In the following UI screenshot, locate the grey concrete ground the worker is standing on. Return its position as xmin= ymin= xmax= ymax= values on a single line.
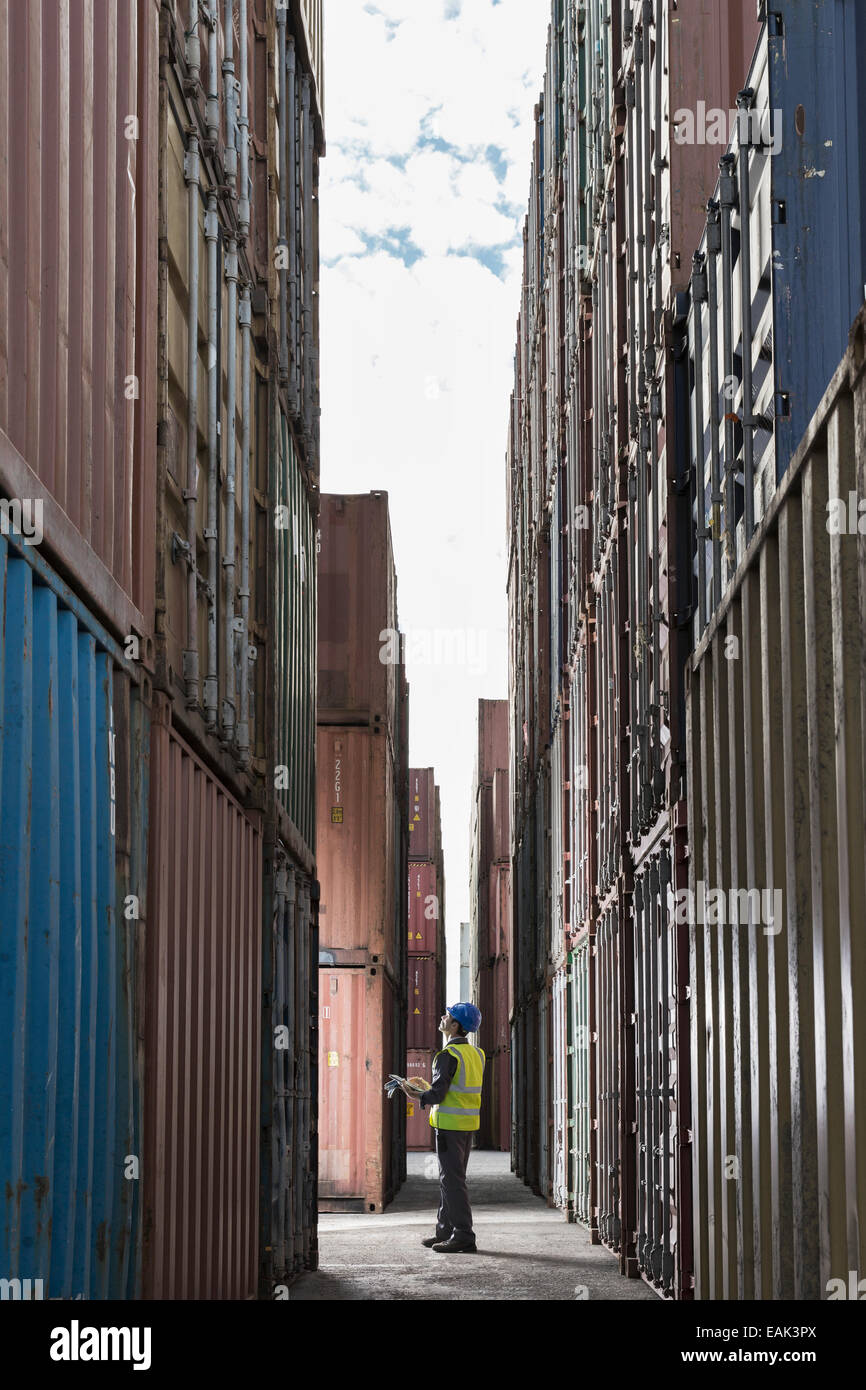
xmin=289 ymin=1151 xmax=657 ymax=1302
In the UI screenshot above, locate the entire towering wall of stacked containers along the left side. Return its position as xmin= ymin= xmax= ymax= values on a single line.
xmin=0 ymin=0 xmax=324 ymax=1298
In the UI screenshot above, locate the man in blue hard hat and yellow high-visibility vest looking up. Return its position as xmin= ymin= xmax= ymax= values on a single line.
xmin=403 ymin=1004 xmax=487 ymax=1255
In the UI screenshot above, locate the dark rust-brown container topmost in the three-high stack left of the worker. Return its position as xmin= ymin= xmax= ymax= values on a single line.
xmin=318 ymin=492 xmax=403 ymax=726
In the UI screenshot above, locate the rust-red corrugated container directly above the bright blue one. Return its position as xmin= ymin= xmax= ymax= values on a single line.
xmin=0 ymin=0 xmax=160 ymax=638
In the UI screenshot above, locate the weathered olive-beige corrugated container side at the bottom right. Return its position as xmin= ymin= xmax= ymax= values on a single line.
xmin=681 ymin=314 xmax=866 ymax=1300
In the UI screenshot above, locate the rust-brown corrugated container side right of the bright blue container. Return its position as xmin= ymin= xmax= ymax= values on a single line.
xmin=142 ymin=699 xmax=263 ymax=1298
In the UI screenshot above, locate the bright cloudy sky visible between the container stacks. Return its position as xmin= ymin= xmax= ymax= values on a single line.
xmin=321 ymin=0 xmax=550 ymax=998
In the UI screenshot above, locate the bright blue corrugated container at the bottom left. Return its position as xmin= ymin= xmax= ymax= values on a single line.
xmin=0 ymin=535 xmax=146 ymax=1298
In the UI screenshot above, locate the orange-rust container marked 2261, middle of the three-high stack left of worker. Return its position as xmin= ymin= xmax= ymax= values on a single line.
xmin=317 ymin=727 xmax=407 ymax=972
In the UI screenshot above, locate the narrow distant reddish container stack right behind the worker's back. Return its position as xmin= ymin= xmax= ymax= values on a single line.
xmin=467 ymin=699 xmax=512 ymax=1151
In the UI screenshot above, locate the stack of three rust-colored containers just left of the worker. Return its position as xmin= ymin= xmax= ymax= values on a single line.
xmin=317 ymin=492 xmax=409 ymax=1211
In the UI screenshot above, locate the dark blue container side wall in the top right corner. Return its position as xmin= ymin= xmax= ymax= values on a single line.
xmin=769 ymin=0 xmax=866 ymax=480
